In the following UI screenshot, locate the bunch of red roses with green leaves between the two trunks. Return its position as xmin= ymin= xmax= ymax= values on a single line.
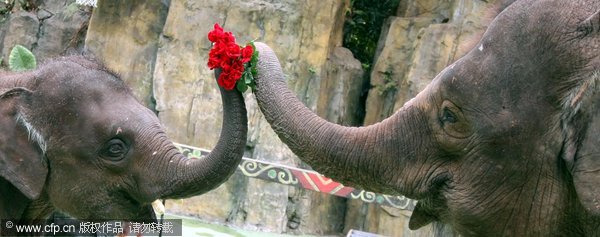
xmin=208 ymin=24 xmax=258 ymax=92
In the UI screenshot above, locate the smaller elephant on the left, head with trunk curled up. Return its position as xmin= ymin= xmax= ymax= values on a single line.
xmin=0 ymin=56 xmax=247 ymax=220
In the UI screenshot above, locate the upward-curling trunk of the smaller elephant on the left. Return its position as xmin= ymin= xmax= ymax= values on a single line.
xmin=144 ymin=74 xmax=248 ymax=199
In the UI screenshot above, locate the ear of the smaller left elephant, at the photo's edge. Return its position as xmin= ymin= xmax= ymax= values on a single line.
xmin=0 ymin=88 xmax=48 ymax=199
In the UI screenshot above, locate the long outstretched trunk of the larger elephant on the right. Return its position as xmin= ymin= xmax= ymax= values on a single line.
xmin=254 ymin=43 xmax=428 ymax=196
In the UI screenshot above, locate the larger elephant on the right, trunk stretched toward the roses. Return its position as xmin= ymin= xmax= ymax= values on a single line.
xmin=253 ymin=0 xmax=600 ymax=236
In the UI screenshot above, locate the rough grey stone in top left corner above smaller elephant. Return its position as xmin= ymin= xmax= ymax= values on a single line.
xmin=0 ymin=0 xmax=91 ymax=66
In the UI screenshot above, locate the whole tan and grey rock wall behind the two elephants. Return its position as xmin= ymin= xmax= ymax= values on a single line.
xmin=0 ymin=0 xmax=506 ymax=236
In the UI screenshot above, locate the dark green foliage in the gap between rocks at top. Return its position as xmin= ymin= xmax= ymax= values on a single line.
xmin=344 ymin=0 xmax=400 ymax=69
